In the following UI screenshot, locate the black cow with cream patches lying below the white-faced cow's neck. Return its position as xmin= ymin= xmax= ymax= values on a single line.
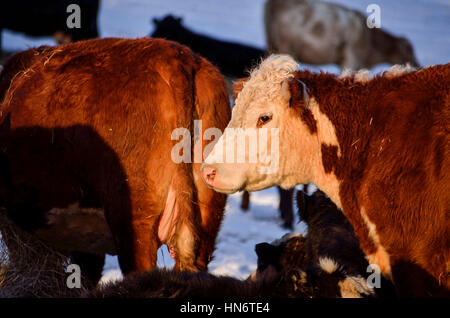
xmin=249 ymin=191 xmax=395 ymax=297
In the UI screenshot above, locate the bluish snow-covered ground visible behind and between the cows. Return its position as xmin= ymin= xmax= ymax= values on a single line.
xmin=3 ymin=0 xmax=450 ymax=281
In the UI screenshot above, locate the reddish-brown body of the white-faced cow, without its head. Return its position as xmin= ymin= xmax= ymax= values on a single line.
xmin=288 ymin=64 xmax=450 ymax=296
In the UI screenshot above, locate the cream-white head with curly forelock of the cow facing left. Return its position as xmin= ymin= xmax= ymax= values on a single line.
xmin=202 ymin=55 xmax=318 ymax=193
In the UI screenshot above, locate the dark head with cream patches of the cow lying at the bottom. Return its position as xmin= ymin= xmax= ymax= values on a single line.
xmin=247 ymin=233 xmax=375 ymax=298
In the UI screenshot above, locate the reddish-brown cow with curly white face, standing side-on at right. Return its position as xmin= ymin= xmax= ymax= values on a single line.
xmin=202 ymin=55 xmax=450 ymax=296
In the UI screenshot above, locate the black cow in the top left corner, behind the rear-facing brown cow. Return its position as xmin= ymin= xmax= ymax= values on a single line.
xmin=0 ymin=0 xmax=100 ymax=50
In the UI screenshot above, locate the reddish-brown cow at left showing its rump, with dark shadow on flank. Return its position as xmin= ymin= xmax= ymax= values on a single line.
xmin=0 ymin=38 xmax=230 ymax=278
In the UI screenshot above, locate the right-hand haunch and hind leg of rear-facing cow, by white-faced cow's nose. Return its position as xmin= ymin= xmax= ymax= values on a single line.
xmin=192 ymin=58 xmax=231 ymax=270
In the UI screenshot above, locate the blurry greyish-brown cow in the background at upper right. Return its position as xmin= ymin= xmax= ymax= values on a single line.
xmin=264 ymin=0 xmax=418 ymax=70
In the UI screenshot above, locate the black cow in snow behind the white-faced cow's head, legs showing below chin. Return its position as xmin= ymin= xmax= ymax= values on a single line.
xmin=151 ymin=15 xmax=294 ymax=229
